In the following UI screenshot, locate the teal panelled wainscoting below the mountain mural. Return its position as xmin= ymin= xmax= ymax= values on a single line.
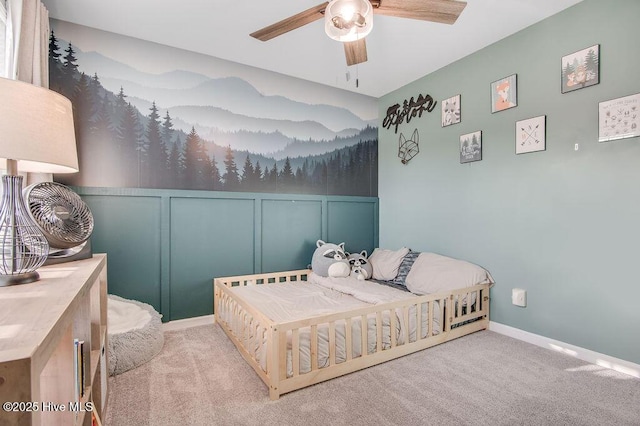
xmin=74 ymin=187 xmax=378 ymax=321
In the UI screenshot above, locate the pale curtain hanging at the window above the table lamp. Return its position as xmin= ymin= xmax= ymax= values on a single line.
xmin=7 ymin=0 xmax=49 ymax=88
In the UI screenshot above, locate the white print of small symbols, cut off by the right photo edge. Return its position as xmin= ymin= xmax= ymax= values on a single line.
xmin=598 ymin=93 xmax=640 ymax=142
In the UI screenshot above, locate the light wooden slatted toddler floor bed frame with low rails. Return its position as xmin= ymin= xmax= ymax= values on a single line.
xmin=213 ymin=269 xmax=490 ymax=400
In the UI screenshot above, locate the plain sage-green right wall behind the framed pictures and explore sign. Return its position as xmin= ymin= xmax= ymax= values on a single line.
xmin=379 ymin=0 xmax=640 ymax=363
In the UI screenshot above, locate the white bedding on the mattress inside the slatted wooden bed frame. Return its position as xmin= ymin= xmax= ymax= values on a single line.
xmin=221 ymin=273 xmax=440 ymax=377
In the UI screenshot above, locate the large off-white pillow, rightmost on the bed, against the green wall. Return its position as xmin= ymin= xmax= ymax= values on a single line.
xmin=404 ymin=253 xmax=494 ymax=294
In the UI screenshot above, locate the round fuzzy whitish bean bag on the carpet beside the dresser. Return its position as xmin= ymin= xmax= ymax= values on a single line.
xmin=107 ymin=294 xmax=164 ymax=376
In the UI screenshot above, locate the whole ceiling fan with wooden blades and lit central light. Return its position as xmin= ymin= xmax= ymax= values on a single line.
xmin=251 ymin=0 xmax=467 ymax=65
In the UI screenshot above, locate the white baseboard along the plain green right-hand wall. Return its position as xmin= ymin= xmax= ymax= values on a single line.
xmin=489 ymin=321 xmax=640 ymax=379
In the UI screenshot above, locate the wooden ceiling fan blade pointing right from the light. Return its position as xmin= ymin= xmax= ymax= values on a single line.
xmin=371 ymin=0 xmax=467 ymax=24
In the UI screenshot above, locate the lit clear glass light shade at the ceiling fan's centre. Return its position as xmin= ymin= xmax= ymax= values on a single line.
xmin=324 ymin=0 xmax=373 ymax=42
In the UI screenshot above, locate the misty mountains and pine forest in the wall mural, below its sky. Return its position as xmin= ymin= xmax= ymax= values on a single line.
xmin=49 ymin=33 xmax=378 ymax=196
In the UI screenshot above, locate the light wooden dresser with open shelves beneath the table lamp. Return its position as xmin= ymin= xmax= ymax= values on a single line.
xmin=0 ymin=254 xmax=109 ymax=426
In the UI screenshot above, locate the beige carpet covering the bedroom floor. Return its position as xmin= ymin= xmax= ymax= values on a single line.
xmin=104 ymin=325 xmax=640 ymax=426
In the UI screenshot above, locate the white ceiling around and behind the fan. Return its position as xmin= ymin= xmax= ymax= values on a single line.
xmin=38 ymin=0 xmax=581 ymax=97
